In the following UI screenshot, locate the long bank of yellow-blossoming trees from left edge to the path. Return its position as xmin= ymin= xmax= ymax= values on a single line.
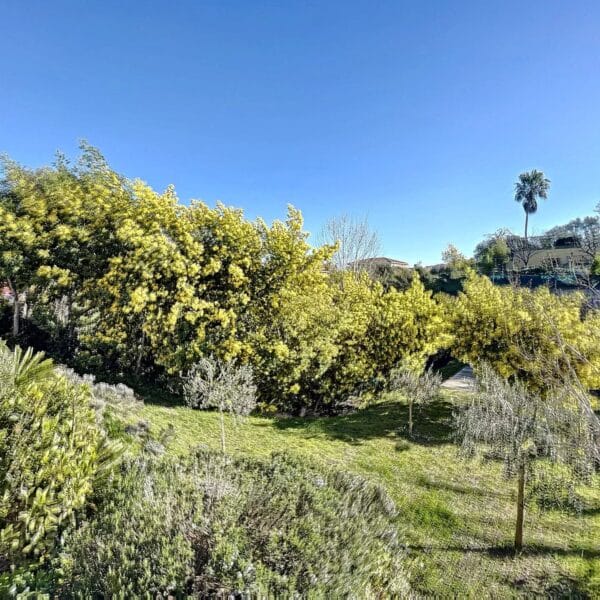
xmin=0 ymin=146 xmax=454 ymax=411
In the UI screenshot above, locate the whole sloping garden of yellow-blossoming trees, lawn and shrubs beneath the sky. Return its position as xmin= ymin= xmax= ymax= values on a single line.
xmin=0 ymin=145 xmax=600 ymax=598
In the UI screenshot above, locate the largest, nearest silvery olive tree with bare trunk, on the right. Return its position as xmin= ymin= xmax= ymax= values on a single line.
xmin=456 ymin=364 xmax=600 ymax=550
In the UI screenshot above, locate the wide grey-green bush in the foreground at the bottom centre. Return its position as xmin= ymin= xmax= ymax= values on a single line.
xmin=59 ymin=451 xmax=408 ymax=598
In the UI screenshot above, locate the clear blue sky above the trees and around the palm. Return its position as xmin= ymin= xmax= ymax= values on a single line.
xmin=0 ymin=0 xmax=600 ymax=264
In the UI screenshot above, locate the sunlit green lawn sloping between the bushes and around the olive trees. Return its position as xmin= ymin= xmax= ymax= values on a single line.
xmin=140 ymin=393 xmax=600 ymax=598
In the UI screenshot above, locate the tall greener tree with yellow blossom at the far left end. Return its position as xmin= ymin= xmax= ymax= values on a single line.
xmin=0 ymin=144 xmax=131 ymax=342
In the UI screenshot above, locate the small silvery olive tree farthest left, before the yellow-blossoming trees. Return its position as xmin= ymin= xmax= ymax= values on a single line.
xmin=182 ymin=357 xmax=256 ymax=453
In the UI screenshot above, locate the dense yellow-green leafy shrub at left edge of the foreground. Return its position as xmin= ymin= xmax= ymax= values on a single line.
xmin=0 ymin=344 xmax=116 ymax=566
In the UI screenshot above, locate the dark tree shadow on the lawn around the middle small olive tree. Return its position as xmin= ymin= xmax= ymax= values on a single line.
xmin=274 ymin=399 xmax=453 ymax=451
